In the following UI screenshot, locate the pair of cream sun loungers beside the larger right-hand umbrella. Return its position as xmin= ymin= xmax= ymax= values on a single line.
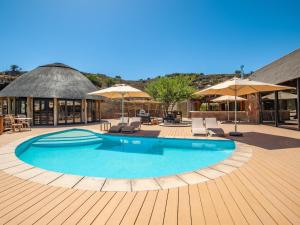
xmin=192 ymin=118 xmax=225 ymax=137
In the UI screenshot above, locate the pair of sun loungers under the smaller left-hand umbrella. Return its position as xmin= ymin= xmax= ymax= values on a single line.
xmin=108 ymin=117 xmax=141 ymax=133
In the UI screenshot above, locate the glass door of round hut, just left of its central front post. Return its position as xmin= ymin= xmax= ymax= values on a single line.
xmin=33 ymin=98 xmax=54 ymax=125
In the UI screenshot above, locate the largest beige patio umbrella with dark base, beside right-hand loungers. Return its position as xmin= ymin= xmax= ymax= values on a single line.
xmin=195 ymin=77 xmax=293 ymax=136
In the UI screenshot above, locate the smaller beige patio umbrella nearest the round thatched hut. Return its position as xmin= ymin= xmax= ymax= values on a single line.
xmin=88 ymin=84 xmax=150 ymax=123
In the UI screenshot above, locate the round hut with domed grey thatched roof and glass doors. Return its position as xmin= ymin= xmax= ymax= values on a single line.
xmin=0 ymin=63 xmax=100 ymax=126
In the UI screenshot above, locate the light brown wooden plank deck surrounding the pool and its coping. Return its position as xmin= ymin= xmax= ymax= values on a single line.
xmin=0 ymin=125 xmax=300 ymax=225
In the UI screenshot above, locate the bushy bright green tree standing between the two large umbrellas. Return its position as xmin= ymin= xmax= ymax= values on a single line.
xmin=146 ymin=76 xmax=195 ymax=113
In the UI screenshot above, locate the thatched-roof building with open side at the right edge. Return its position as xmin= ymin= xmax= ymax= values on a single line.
xmin=250 ymin=49 xmax=300 ymax=130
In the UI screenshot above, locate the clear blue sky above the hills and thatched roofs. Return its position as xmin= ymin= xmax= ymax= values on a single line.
xmin=0 ymin=0 xmax=300 ymax=79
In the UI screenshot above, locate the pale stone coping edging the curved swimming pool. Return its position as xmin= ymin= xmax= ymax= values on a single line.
xmin=0 ymin=128 xmax=252 ymax=191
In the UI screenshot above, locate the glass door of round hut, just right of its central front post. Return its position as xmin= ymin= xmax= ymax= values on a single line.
xmin=58 ymin=99 xmax=82 ymax=124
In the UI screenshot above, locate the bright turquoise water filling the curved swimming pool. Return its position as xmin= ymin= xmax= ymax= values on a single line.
xmin=16 ymin=129 xmax=235 ymax=178
